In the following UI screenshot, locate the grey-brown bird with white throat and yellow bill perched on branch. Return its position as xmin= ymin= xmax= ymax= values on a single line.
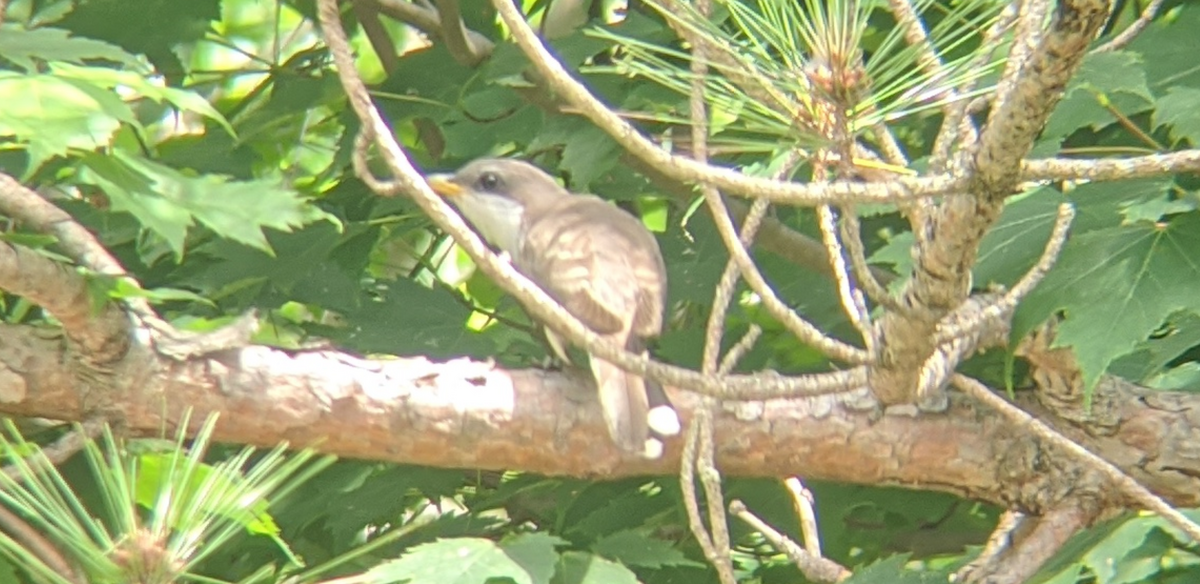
xmin=428 ymin=158 xmax=679 ymax=458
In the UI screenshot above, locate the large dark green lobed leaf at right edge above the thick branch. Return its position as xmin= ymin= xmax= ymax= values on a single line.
xmin=1013 ymin=212 xmax=1200 ymax=387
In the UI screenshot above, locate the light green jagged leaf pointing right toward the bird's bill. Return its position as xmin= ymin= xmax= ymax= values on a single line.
xmin=79 ymin=151 xmax=331 ymax=258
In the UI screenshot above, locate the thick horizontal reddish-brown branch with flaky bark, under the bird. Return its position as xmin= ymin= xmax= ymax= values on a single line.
xmin=0 ymin=326 xmax=1200 ymax=512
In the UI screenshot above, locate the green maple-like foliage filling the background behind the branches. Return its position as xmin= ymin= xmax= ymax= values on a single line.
xmin=0 ymin=0 xmax=1200 ymax=583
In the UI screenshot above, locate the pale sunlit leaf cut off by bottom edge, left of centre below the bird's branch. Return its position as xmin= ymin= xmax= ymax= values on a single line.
xmin=362 ymin=537 xmax=538 ymax=584
